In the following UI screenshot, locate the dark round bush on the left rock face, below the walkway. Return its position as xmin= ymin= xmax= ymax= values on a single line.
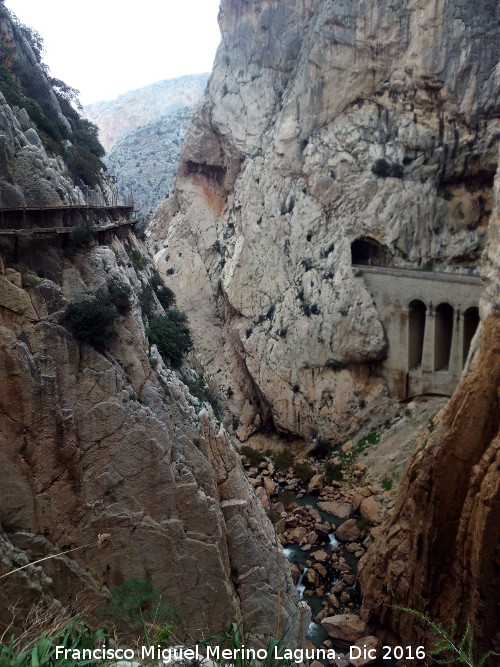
xmin=63 ymin=297 xmax=118 ymax=348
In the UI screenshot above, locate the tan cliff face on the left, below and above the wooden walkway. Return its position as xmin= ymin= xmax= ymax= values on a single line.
xmin=0 ymin=3 xmax=296 ymax=637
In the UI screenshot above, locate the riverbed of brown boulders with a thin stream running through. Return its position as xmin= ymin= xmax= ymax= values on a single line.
xmin=243 ymin=449 xmax=390 ymax=667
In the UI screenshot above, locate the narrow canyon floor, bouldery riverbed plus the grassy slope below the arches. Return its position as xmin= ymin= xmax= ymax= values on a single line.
xmin=236 ymin=396 xmax=448 ymax=664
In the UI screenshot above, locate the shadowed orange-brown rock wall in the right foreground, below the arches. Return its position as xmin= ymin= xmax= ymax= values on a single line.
xmin=360 ymin=154 xmax=500 ymax=664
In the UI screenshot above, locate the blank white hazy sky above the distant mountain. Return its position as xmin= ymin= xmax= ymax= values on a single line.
xmin=5 ymin=0 xmax=220 ymax=104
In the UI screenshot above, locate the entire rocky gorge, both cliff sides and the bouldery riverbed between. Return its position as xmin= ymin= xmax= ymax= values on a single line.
xmin=0 ymin=0 xmax=500 ymax=667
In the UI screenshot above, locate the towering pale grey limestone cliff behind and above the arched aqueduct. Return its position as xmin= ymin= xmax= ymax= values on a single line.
xmin=150 ymin=0 xmax=498 ymax=440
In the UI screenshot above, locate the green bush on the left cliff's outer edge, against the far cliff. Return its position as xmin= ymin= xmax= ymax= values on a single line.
xmin=148 ymin=308 xmax=193 ymax=368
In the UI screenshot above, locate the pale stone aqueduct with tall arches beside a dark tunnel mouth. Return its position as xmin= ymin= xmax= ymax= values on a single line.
xmin=353 ymin=241 xmax=483 ymax=400
